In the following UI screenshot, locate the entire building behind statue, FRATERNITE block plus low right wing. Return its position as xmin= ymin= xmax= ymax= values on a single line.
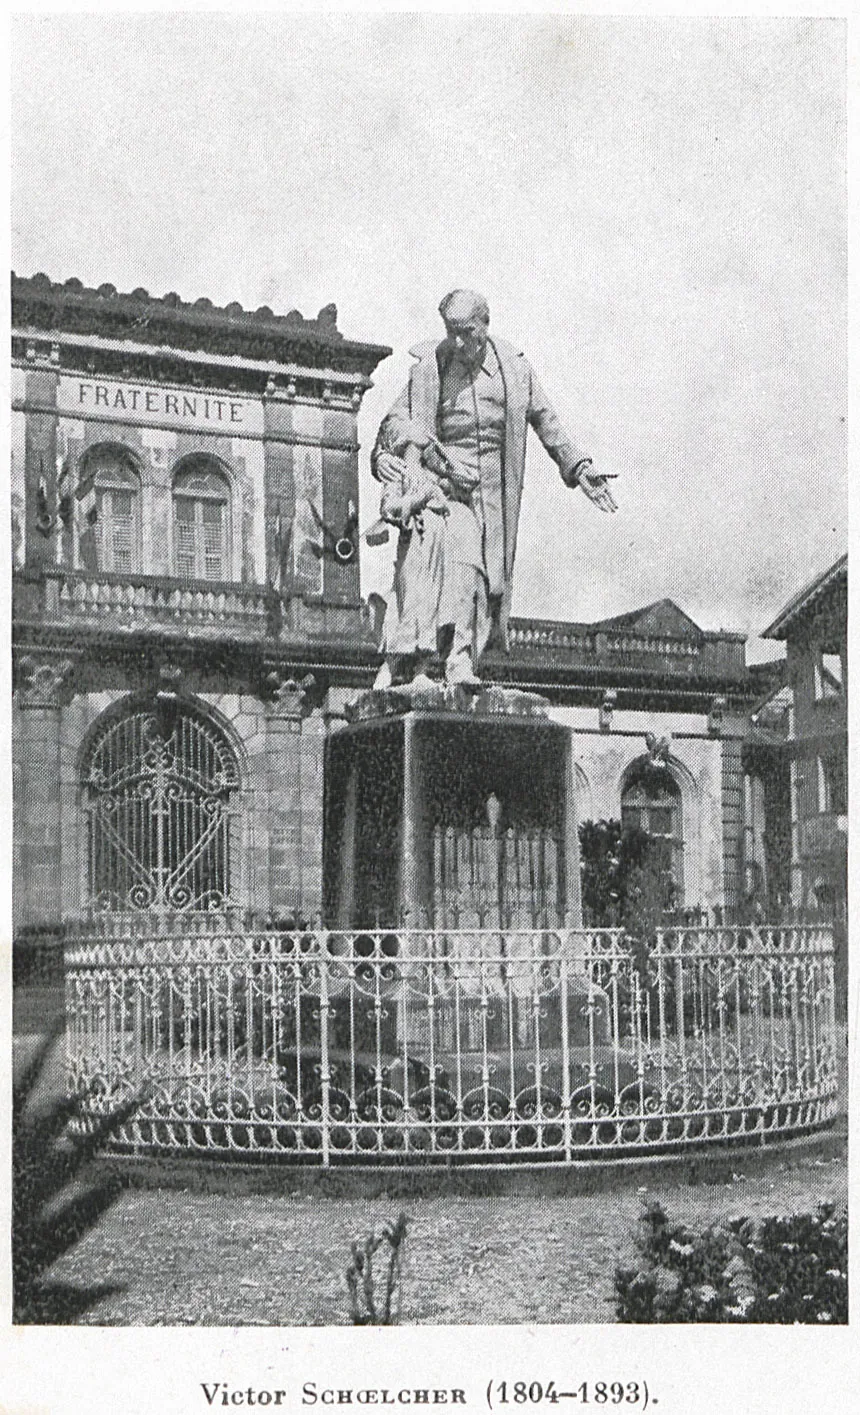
xmin=11 ymin=276 xmax=763 ymax=962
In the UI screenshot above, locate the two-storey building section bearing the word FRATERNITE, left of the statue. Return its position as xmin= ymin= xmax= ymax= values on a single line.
xmin=11 ymin=276 xmax=389 ymax=927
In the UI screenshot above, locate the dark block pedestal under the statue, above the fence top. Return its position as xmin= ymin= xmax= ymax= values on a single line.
xmin=324 ymin=685 xmax=581 ymax=930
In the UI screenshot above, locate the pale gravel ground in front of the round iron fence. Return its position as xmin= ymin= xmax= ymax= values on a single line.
xmin=42 ymin=1155 xmax=846 ymax=1326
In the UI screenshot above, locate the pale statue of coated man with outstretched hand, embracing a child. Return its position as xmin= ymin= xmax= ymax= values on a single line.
xmin=371 ymin=290 xmax=617 ymax=688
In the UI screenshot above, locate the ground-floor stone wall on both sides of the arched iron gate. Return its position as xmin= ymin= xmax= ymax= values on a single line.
xmin=13 ymin=668 xmax=324 ymax=930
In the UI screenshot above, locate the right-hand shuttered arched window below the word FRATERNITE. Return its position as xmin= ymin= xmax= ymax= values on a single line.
xmin=173 ymin=457 xmax=231 ymax=580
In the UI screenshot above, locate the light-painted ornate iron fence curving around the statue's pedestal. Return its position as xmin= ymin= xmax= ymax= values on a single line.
xmin=66 ymin=918 xmax=836 ymax=1165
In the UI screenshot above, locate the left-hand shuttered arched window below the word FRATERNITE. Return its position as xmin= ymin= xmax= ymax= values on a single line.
xmin=78 ymin=443 xmax=140 ymax=574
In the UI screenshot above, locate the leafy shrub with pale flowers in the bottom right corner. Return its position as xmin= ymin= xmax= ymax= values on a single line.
xmin=615 ymin=1203 xmax=849 ymax=1324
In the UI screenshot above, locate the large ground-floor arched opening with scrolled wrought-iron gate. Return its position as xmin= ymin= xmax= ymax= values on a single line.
xmin=82 ymin=699 xmax=239 ymax=910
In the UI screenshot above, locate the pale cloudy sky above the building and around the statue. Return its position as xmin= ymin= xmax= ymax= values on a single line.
xmin=11 ymin=13 xmax=847 ymax=658
